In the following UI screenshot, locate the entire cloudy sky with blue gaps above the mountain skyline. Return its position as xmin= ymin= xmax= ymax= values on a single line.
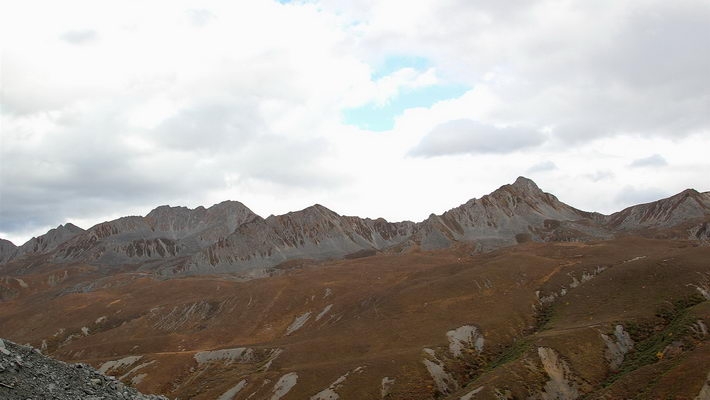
xmin=0 ymin=0 xmax=710 ymax=244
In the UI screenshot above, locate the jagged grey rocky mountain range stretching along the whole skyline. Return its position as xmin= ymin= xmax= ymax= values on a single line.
xmin=0 ymin=177 xmax=710 ymax=275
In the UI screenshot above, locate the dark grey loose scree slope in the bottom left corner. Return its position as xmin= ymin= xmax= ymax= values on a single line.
xmin=0 ymin=339 xmax=167 ymax=400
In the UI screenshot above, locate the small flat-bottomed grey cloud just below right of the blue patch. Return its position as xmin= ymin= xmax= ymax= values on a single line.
xmin=409 ymin=119 xmax=545 ymax=157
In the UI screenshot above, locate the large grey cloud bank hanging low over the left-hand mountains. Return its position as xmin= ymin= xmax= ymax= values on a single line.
xmin=0 ymin=98 xmax=345 ymax=239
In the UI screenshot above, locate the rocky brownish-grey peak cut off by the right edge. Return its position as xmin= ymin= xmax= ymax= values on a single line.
xmin=606 ymin=189 xmax=710 ymax=231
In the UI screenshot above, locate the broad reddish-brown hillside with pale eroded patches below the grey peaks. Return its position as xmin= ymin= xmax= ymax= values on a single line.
xmin=0 ymin=237 xmax=710 ymax=400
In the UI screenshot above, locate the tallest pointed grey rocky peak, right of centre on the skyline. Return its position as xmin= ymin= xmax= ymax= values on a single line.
xmin=415 ymin=177 xmax=606 ymax=249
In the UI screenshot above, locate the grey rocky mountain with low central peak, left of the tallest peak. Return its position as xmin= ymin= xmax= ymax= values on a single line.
xmin=188 ymin=204 xmax=415 ymax=271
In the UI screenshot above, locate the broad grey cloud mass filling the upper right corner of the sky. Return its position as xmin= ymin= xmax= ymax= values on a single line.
xmin=350 ymin=0 xmax=710 ymax=144
